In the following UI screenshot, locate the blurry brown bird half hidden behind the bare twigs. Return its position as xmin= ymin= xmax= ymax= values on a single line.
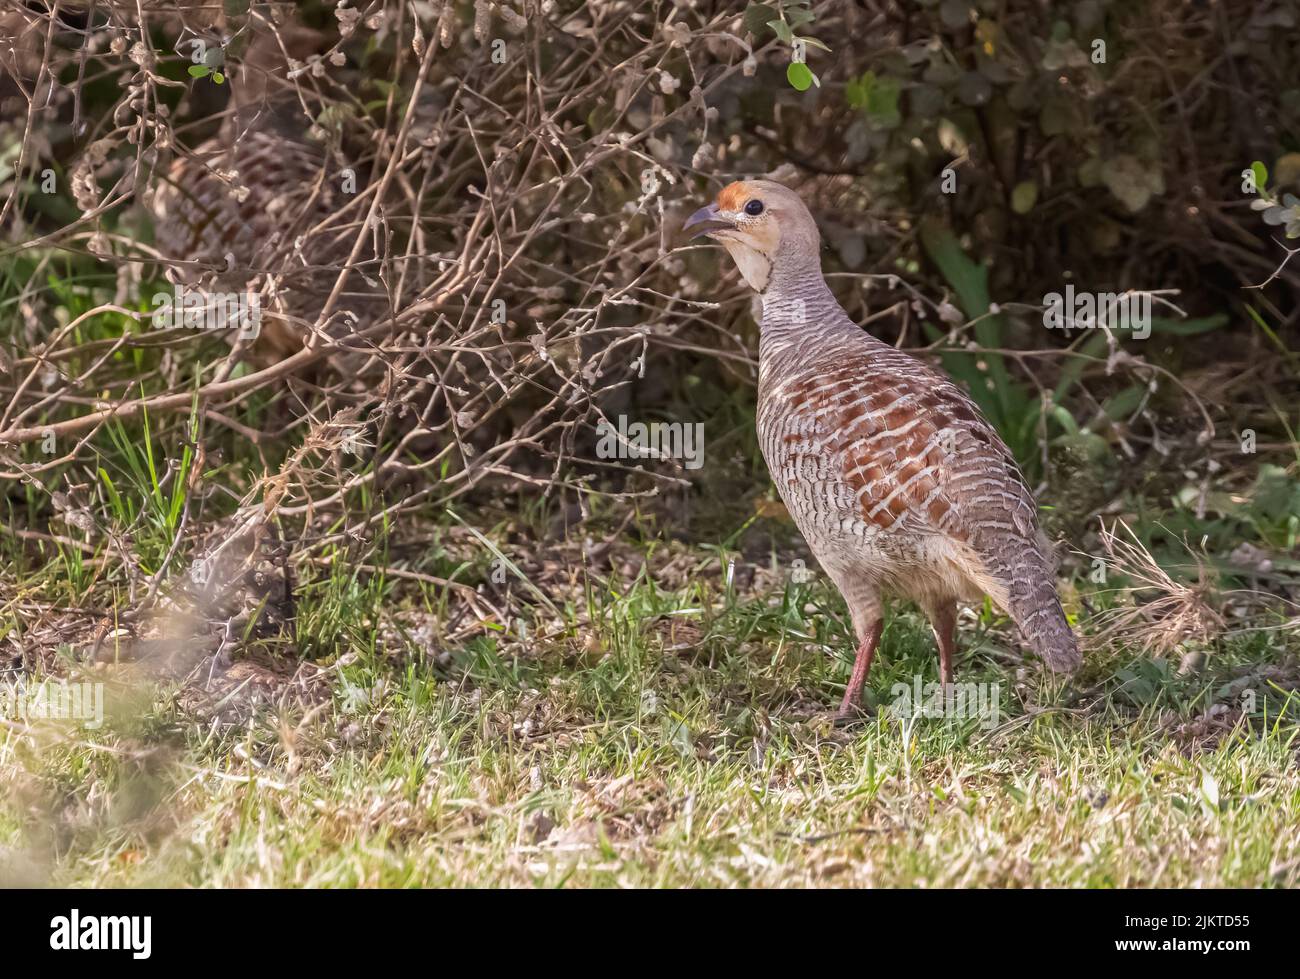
xmin=150 ymin=21 xmax=380 ymax=360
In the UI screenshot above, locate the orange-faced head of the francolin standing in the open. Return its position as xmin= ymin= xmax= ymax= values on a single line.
xmin=684 ymin=181 xmax=820 ymax=293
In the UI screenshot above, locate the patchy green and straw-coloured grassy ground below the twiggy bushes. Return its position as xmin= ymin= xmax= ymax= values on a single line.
xmin=0 ymin=252 xmax=1300 ymax=887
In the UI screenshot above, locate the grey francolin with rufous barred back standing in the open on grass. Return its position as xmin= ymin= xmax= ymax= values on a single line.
xmin=686 ymin=181 xmax=1080 ymax=715
